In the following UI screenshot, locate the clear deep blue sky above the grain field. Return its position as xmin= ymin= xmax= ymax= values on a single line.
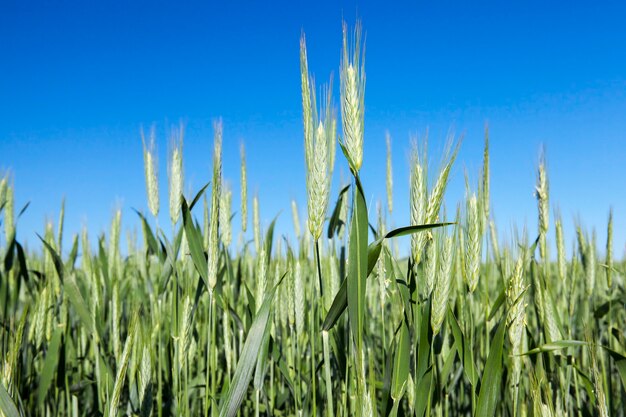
xmin=0 ymin=0 xmax=626 ymax=255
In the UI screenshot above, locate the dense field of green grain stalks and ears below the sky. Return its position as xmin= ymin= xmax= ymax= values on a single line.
xmin=0 ymin=22 xmax=626 ymax=417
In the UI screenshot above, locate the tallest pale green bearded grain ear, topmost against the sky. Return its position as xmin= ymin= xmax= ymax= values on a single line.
xmin=340 ymin=22 xmax=365 ymax=172
